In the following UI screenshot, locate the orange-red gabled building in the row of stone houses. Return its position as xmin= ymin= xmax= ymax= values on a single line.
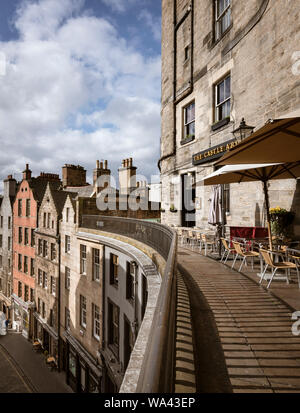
xmin=12 ymin=165 xmax=61 ymax=339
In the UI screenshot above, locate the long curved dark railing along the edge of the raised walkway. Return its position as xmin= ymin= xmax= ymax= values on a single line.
xmin=81 ymin=215 xmax=177 ymax=393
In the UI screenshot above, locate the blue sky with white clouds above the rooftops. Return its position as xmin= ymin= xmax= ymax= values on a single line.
xmin=0 ymin=0 xmax=161 ymax=189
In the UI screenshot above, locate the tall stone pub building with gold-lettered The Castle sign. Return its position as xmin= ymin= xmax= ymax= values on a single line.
xmin=159 ymin=0 xmax=300 ymax=232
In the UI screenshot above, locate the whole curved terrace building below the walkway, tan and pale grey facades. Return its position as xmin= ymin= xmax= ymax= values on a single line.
xmin=60 ymin=194 xmax=157 ymax=392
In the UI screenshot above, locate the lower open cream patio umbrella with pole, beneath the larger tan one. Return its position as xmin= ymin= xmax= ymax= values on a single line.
xmin=197 ymin=161 xmax=300 ymax=249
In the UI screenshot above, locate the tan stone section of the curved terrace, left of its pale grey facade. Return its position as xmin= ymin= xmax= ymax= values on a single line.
xmin=60 ymin=195 xmax=103 ymax=393
